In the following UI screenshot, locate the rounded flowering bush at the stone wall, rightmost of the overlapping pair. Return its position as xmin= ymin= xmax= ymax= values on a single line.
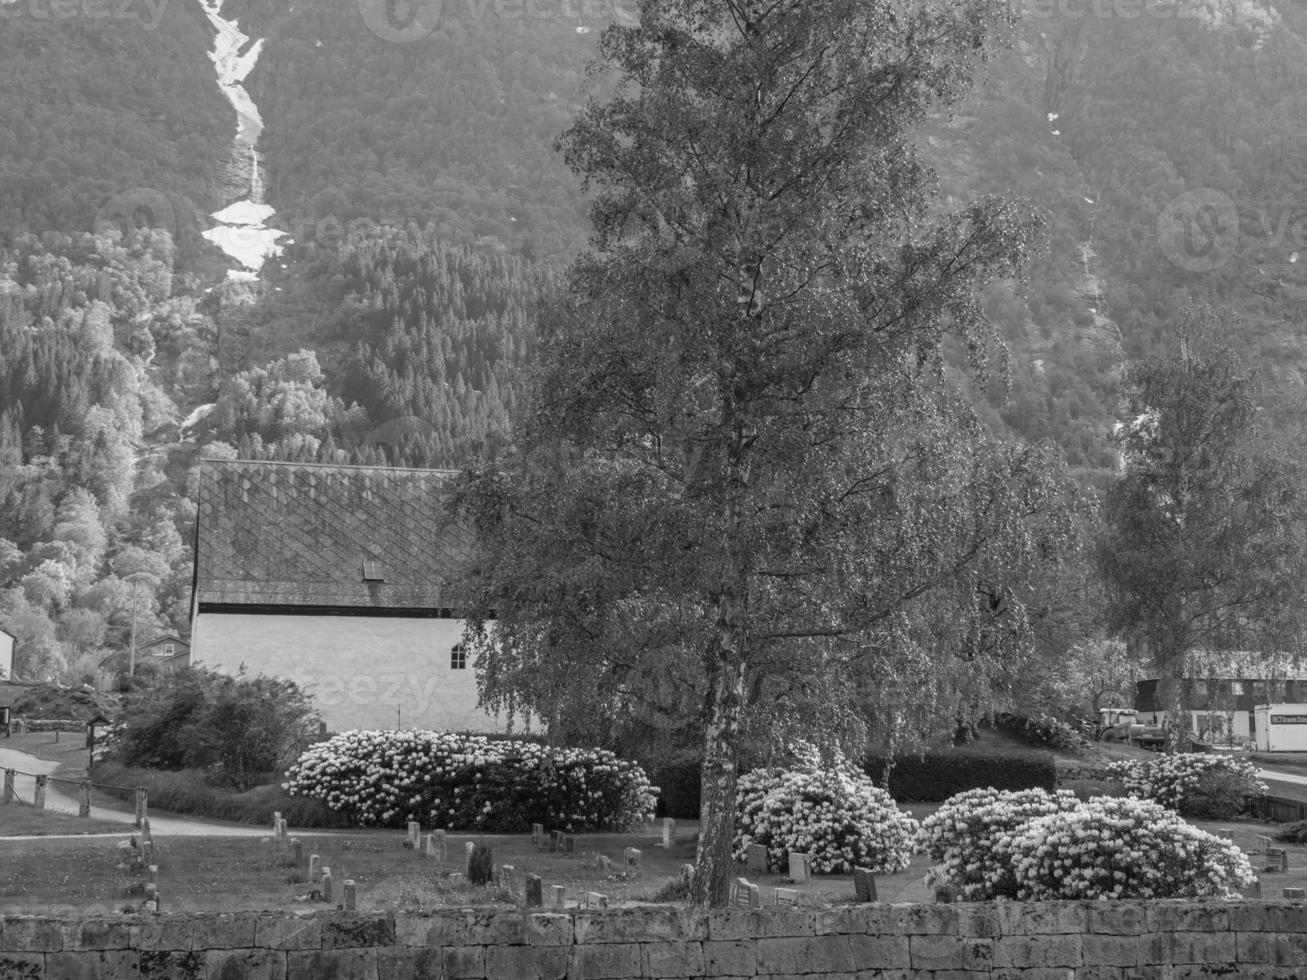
xmin=995 ymin=798 xmax=1252 ymax=900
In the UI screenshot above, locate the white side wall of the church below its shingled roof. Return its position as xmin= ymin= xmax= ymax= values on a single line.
xmin=191 ymin=613 xmax=520 ymax=732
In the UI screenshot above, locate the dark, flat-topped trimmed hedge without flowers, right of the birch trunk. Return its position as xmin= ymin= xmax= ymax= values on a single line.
xmin=863 ymin=750 xmax=1057 ymax=804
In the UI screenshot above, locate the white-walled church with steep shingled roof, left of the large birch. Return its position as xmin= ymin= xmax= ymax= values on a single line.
xmin=191 ymin=460 xmax=507 ymax=732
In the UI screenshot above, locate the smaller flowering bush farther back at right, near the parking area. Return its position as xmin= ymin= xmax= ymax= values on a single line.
xmin=1107 ymin=753 xmax=1266 ymax=819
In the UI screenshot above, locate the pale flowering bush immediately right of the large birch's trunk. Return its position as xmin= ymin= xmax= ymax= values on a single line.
xmin=735 ymin=767 xmax=916 ymax=874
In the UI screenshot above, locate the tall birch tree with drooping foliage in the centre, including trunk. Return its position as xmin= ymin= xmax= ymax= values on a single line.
xmin=460 ymin=0 xmax=1073 ymax=904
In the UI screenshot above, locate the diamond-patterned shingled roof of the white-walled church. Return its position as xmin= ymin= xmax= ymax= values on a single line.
xmin=195 ymin=460 xmax=471 ymax=614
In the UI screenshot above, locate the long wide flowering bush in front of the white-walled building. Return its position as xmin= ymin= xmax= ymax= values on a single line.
xmin=282 ymin=732 xmax=657 ymax=831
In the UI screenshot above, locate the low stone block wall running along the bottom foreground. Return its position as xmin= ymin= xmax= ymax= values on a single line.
xmin=0 ymin=900 xmax=1307 ymax=980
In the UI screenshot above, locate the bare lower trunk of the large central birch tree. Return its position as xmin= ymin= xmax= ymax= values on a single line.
xmin=690 ymin=649 xmax=745 ymax=908
